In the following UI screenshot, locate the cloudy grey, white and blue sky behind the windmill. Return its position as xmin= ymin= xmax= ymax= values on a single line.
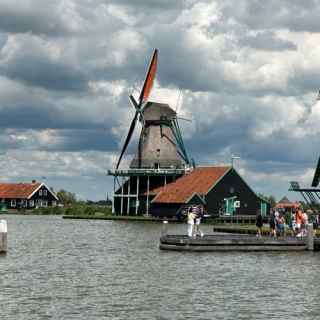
xmin=0 ymin=0 xmax=320 ymax=200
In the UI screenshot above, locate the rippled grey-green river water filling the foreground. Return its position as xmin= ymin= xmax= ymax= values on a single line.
xmin=0 ymin=215 xmax=320 ymax=320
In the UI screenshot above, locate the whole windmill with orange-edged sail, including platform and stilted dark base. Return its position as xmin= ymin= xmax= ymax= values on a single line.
xmin=108 ymin=49 xmax=194 ymax=215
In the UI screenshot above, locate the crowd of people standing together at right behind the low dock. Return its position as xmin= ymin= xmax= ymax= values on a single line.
xmin=256 ymin=209 xmax=309 ymax=237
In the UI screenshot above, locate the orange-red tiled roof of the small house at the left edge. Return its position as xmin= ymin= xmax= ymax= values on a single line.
xmin=0 ymin=182 xmax=41 ymax=199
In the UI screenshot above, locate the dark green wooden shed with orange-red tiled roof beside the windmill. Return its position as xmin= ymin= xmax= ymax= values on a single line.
xmin=150 ymin=166 xmax=266 ymax=216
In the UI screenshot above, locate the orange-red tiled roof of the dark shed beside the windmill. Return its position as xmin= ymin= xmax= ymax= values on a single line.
xmin=150 ymin=166 xmax=230 ymax=203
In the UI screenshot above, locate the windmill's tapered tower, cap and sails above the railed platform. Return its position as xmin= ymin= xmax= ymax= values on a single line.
xmin=116 ymin=49 xmax=192 ymax=169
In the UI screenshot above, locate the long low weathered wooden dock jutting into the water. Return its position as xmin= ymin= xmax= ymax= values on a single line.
xmin=160 ymin=223 xmax=320 ymax=252
